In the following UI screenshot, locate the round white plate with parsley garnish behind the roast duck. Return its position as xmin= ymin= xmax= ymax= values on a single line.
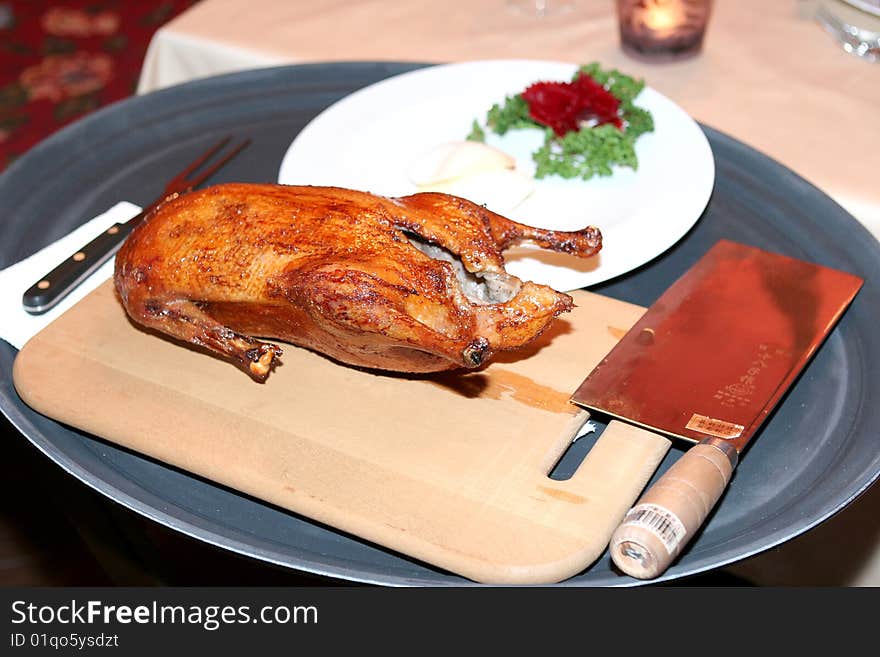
xmin=278 ymin=60 xmax=715 ymax=291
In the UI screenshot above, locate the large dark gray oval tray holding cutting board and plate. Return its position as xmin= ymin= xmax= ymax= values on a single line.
xmin=0 ymin=62 xmax=880 ymax=586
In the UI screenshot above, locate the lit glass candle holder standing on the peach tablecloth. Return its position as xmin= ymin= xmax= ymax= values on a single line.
xmin=617 ymin=0 xmax=712 ymax=61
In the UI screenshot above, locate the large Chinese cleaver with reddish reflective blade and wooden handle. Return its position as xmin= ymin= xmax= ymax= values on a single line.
xmin=571 ymin=240 xmax=864 ymax=579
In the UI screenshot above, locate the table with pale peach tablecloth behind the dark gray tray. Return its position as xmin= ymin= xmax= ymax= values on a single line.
xmin=131 ymin=0 xmax=880 ymax=586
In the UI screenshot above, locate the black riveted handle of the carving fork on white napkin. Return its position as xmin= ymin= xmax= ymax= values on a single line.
xmin=22 ymin=221 xmax=135 ymax=315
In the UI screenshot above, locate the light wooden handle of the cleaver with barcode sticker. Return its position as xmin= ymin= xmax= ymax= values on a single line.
xmin=610 ymin=438 xmax=738 ymax=579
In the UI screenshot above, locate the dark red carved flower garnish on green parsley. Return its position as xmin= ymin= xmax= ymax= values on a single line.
xmin=522 ymin=73 xmax=623 ymax=137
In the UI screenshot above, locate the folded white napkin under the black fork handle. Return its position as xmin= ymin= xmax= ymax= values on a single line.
xmin=0 ymin=201 xmax=141 ymax=349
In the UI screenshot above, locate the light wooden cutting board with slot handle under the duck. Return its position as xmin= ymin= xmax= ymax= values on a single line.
xmin=13 ymin=281 xmax=669 ymax=584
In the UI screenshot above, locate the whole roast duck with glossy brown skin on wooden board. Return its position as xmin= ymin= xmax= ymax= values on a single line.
xmin=114 ymin=184 xmax=601 ymax=381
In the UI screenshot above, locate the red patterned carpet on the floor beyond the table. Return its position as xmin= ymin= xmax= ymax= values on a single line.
xmin=0 ymin=0 xmax=196 ymax=171
